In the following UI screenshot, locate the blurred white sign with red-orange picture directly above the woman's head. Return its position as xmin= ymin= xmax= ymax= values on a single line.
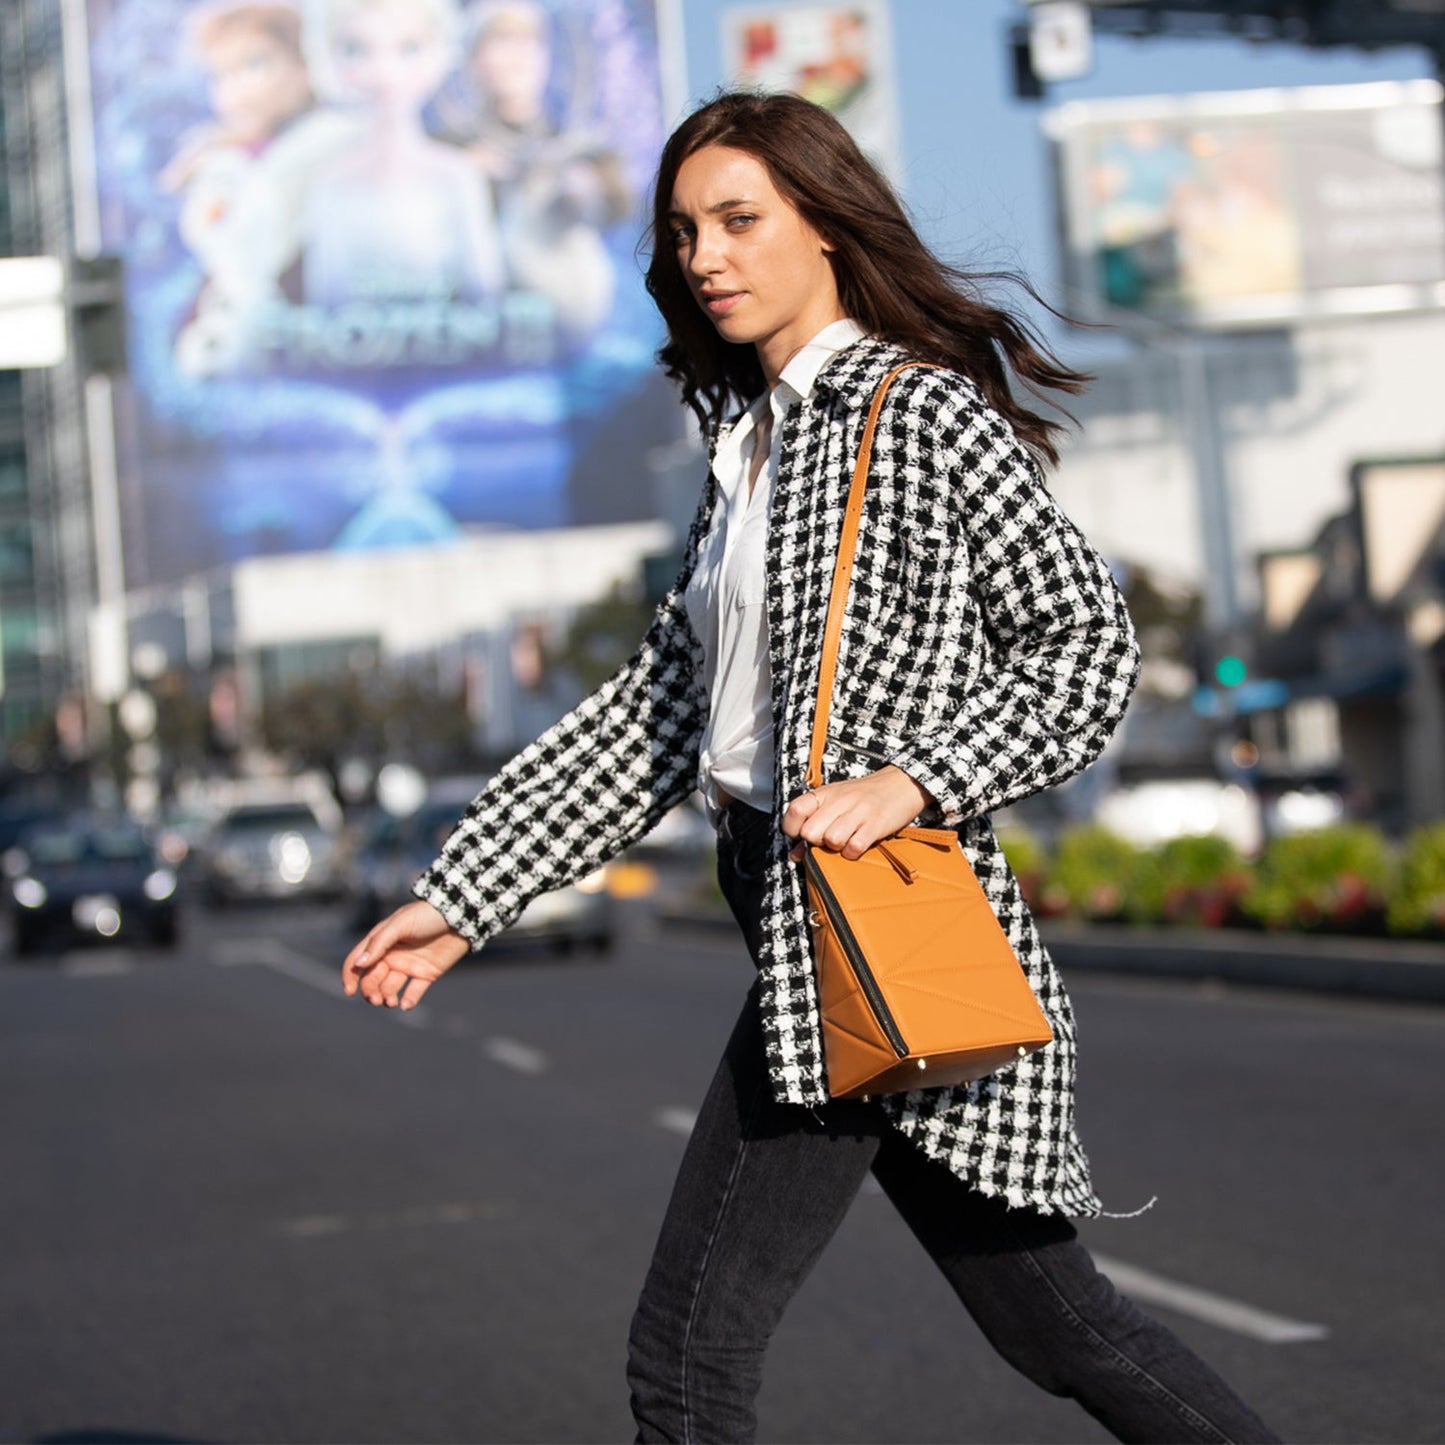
xmin=723 ymin=0 xmax=900 ymax=184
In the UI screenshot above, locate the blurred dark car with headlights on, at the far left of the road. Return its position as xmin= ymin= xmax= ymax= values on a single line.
xmin=4 ymin=818 xmax=176 ymax=955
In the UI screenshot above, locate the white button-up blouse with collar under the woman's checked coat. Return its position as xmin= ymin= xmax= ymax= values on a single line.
xmin=685 ymin=321 xmax=864 ymax=816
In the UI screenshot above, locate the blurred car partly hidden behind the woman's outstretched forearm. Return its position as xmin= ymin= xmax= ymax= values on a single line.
xmin=348 ymin=777 xmax=614 ymax=952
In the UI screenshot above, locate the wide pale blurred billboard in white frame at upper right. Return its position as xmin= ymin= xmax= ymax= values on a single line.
xmin=1045 ymin=81 xmax=1445 ymax=327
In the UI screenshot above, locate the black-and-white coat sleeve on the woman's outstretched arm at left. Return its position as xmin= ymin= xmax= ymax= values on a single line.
xmin=413 ymin=486 xmax=712 ymax=948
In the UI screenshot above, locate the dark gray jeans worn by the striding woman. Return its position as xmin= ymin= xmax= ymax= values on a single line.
xmin=629 ymin=803 xmax=1277 ymax=1445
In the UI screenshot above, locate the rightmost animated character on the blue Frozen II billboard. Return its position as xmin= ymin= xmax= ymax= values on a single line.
xmin=441 ymin=0 xmax=633 ymax=340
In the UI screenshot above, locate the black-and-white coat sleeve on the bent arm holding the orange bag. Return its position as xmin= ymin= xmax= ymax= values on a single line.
xmin=893 ymin=389 xmax=1139 ymax=825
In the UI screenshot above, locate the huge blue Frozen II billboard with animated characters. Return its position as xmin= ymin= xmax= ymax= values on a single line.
xmin=84 ymin=0 xmax=679 ymax=588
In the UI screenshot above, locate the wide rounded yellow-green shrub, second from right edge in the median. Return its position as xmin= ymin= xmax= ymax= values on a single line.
xmin=1241 ymin=824 xmax=1390 ymax=932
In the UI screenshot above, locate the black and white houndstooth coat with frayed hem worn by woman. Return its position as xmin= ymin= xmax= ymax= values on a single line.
xmin=416 ymin=341 xmax=1137 ymax=1214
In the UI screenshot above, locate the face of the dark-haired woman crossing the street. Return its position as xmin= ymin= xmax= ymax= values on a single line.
xmin=669 ymin=146 xmax=844 ymax=384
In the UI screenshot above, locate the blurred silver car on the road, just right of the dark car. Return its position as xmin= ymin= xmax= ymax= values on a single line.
xmin=199 ymin=798 xmax=345 ymax=905
